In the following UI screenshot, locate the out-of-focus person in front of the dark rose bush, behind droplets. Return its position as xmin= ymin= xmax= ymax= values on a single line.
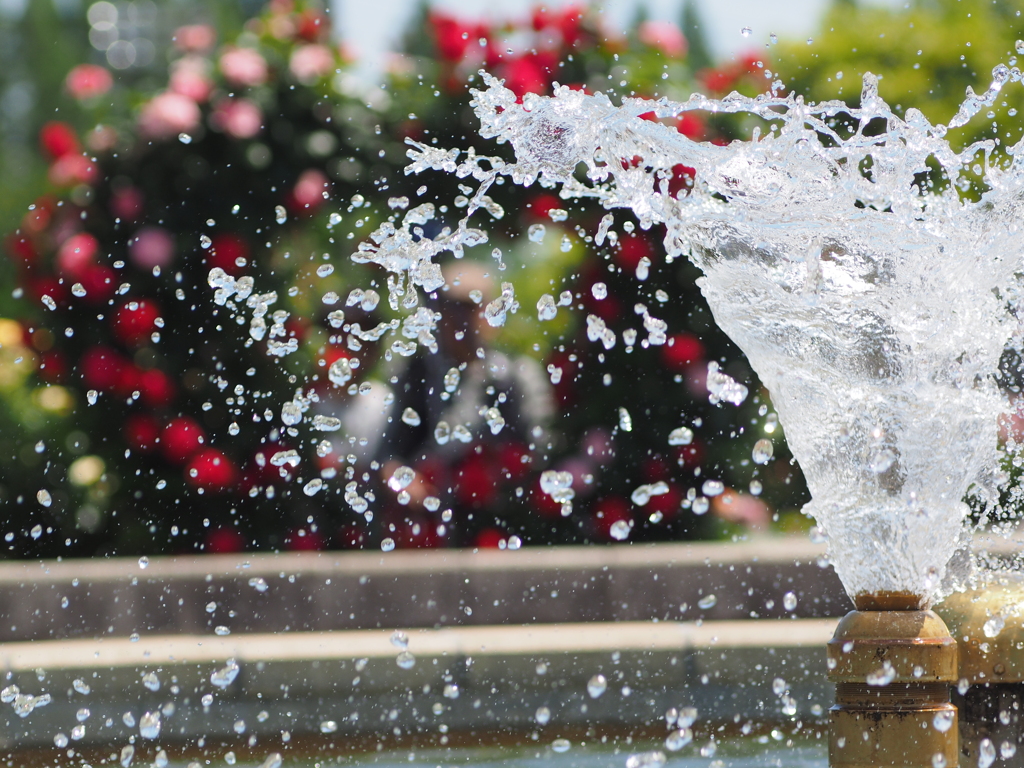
xmin=380 ymin=260 xmax=554 ymax=546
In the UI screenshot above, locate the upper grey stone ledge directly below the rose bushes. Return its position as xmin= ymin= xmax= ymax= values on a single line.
xmin=0 ymin=538 xmax=851 ymax=642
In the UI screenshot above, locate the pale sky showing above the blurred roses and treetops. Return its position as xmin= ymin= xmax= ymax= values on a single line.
xmin=331 ymin=0 xmax=904 ymax=76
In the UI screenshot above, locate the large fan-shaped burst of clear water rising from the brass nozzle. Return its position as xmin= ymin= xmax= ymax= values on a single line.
xmin=399 ymin=66 xmax=1024 ymax=603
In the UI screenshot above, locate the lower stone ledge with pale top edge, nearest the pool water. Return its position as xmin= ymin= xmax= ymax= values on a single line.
xmin=0 ymin=620 xmax=837 ymax=749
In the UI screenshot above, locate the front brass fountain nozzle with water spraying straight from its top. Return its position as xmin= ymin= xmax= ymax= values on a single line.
xmin=828 ymin=595 xmax=959 ymax=768
